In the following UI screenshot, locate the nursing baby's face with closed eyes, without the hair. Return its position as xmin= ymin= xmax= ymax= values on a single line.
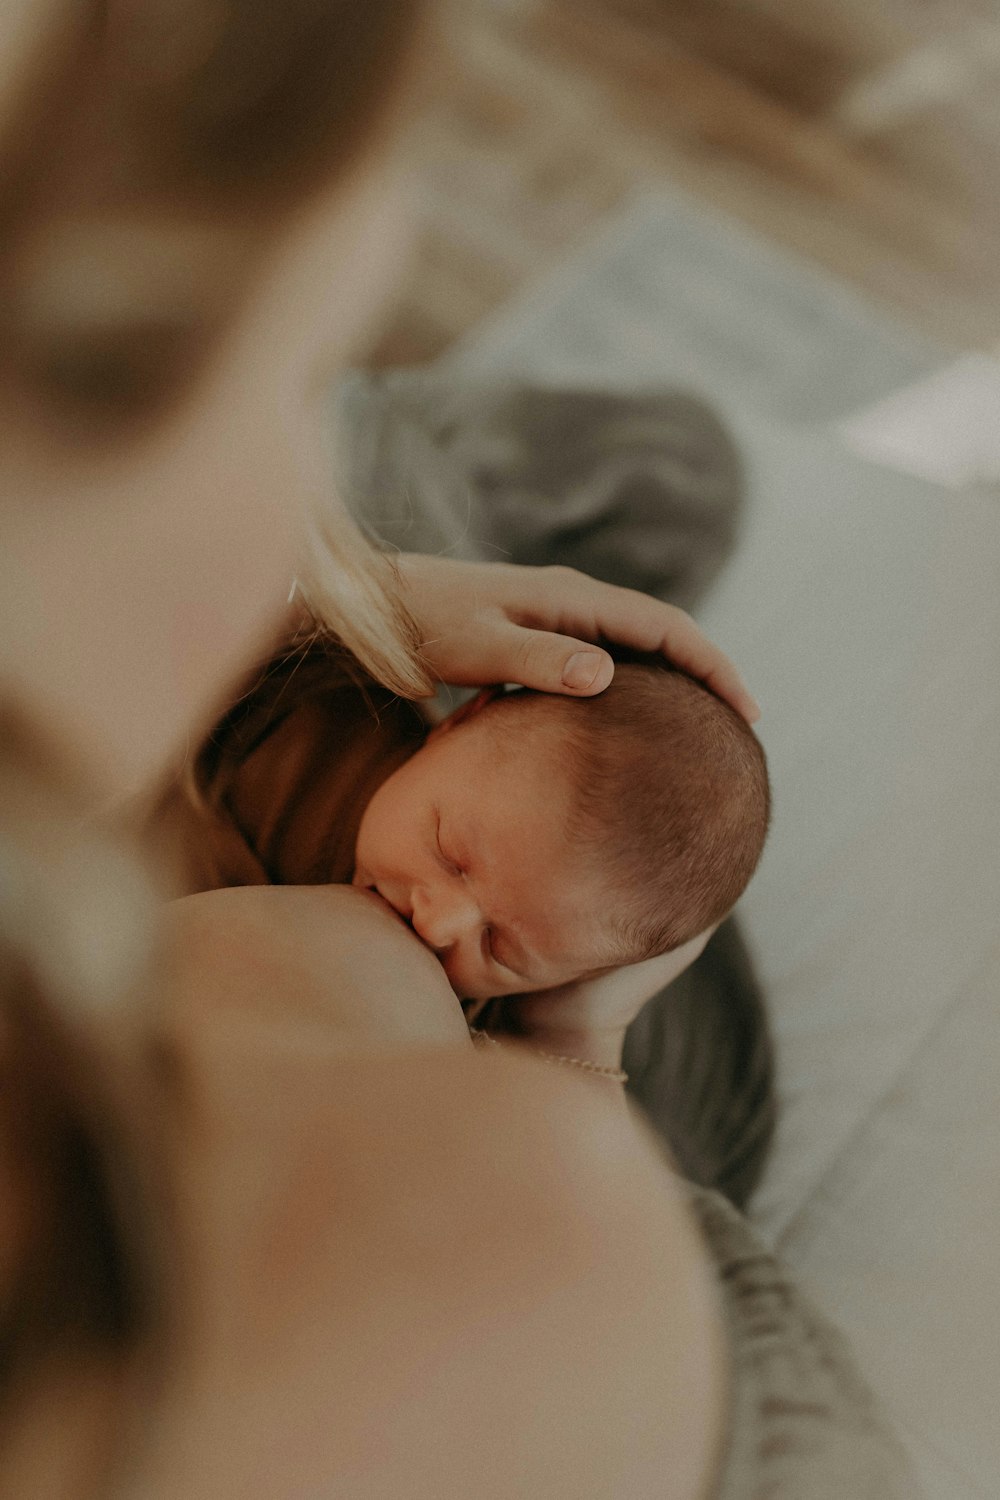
xmin=354 ymin=723 xmax=609 ymax=999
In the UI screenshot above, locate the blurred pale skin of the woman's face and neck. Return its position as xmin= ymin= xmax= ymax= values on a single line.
xmin=0 ymin=143 xmax=405 ymax=798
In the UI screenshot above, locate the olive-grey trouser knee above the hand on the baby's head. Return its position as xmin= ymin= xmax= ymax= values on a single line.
xmin=337 ymin=371 xmax=742 ymax=609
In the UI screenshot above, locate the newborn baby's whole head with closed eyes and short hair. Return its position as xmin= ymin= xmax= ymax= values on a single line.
xmin=354 ymin=663 xmax=769 ymax=999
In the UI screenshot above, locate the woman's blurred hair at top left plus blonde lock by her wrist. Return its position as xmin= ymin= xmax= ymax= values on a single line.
xmin=0 ymin=0 xmax=430 ymax=696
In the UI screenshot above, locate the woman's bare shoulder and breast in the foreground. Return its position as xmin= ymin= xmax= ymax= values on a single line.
xmin=0 ymin=888 xmax=726 ymax=1500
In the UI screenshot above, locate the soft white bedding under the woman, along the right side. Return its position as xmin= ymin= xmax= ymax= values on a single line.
xmin=453 ymin=195 xmax=1000 ymax=1500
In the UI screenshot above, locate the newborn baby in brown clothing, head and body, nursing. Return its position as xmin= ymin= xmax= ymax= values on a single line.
xmin=159 ymin=647 xmax=769 ymax=1001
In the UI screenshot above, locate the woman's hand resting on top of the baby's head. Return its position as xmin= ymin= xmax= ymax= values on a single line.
xmin=399 ymin=554 xmax=760 ymax=723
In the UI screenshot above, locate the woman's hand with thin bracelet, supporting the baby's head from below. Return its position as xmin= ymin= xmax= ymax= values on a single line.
xmin=477 ymin=927 xmax=715 ymax=1068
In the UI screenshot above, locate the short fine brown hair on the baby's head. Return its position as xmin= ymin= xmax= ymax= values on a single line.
xmin=479 ymin=660 xmax=771 ymax=966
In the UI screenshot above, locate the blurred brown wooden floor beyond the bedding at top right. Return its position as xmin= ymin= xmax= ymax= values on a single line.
xmin=372 ymin=0 xmax=1000 ymax=365
